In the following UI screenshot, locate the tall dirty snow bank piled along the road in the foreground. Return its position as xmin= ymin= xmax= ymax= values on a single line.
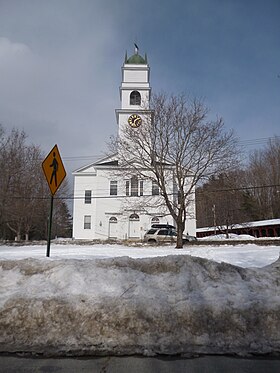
xmin=0 ymin=255 xmax=280 ymax=356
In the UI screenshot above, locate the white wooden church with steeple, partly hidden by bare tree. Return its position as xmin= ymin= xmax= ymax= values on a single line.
xmin=73 ymin=48 xmax=196 ymax=240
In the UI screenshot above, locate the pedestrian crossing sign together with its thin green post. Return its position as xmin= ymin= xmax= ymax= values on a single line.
xmin=42 ymin=145 xmax=66 ymax=257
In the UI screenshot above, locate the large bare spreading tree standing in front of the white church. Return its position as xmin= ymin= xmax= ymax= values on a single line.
xmin=111 ymin=94 xmax=237 ymax=248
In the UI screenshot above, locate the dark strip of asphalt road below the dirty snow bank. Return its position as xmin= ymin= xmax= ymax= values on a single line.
xmin=0 ymin=356 xmax=280 ymax=373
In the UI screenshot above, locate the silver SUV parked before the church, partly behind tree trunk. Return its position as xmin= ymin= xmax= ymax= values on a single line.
xmin=144 ymin=227 xmax=197 ymax=244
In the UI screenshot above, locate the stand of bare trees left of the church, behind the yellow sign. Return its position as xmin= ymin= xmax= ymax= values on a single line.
xmin=0 ymin=127 xmax=69 ymax=240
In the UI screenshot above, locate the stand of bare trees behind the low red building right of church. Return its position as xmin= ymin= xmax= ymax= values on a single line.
xmin=197 ymin=136 xmax=280 ymax=227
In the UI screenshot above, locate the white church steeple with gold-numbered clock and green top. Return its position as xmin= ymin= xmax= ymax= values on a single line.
xmin=116 ymin=44 xmax=151 ymax=137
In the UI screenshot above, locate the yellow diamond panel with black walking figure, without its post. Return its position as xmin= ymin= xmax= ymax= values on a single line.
xmin=42 ymin=145 xmax=66 ymax=195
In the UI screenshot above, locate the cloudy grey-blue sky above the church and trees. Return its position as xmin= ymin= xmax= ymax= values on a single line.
xmin=0 ymin=0 xmax=280 ymax=172
